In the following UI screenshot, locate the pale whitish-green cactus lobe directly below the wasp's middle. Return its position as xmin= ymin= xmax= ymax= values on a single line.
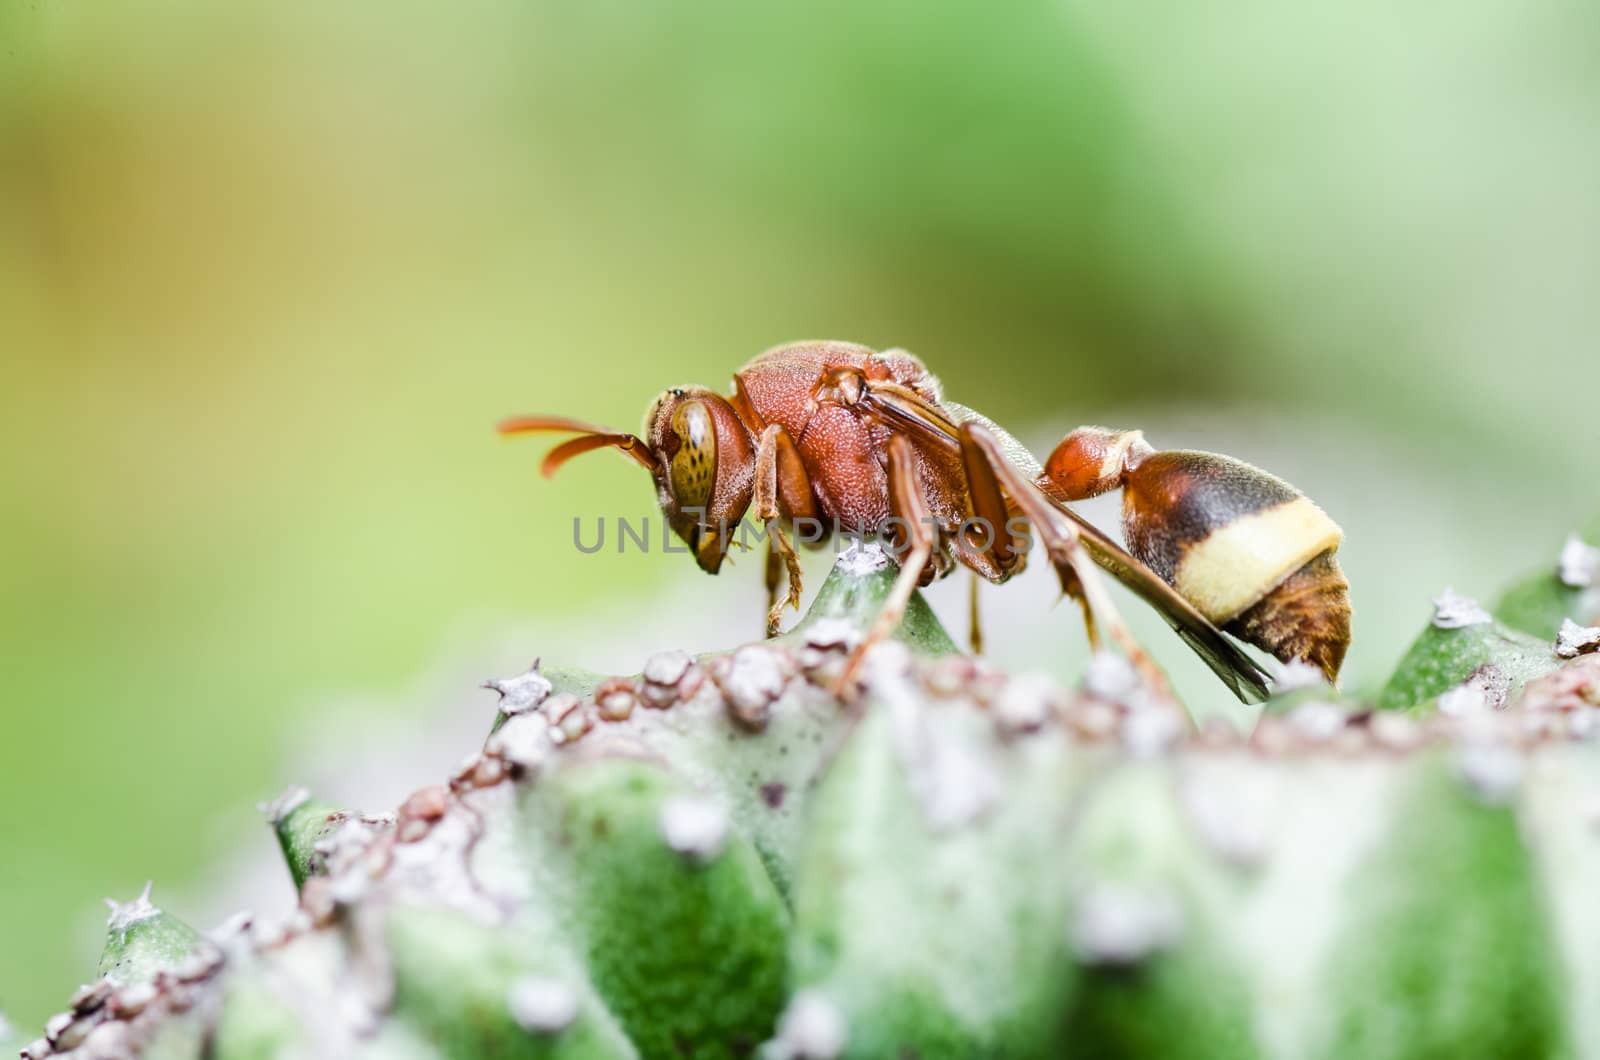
xmin=790 ymin=679 xmax=1090 ymax=1058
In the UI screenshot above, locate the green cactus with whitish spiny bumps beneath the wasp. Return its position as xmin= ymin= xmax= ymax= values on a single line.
xmin=12 ymin=548 xmax=1600 ymax=1060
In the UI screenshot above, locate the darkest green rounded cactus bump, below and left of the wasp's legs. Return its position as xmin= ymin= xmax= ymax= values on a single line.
xmin=523 ymin=759 xmax=787 ymax=1057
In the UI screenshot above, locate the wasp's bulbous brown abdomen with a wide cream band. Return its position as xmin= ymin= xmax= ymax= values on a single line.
xmin=1123 ymin=450 xmax=1350 ymax=681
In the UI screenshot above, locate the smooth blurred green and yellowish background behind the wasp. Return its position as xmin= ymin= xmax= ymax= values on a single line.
xmin=0 ymin=0 xmax=1600 ymax=1025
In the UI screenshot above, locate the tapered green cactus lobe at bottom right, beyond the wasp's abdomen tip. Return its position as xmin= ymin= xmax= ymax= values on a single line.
xmin=1325 ymin=749 xmax=1566 ymax=1060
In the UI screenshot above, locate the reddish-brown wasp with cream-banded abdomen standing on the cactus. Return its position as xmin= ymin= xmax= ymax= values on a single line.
xmin=499 ymin=341 xmax=1350 ymax=701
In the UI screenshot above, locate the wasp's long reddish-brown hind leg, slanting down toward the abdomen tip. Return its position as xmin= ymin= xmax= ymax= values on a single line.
xmin=960 ymin=423 xmax=1171 ymax=695
